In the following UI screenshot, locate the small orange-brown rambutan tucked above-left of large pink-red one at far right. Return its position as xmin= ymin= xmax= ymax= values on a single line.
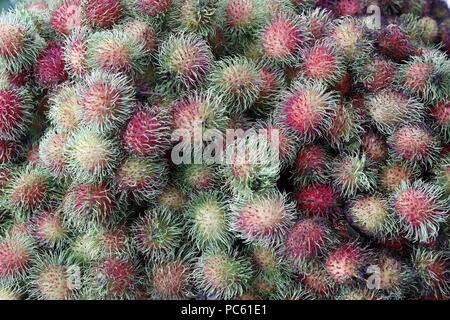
xmin=378 ymin=161 xmax=418 ymax=193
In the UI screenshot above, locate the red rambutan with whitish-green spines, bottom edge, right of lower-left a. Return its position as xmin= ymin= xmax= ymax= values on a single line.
xmin=84 ymin=257 xmax=141 ymax=300
